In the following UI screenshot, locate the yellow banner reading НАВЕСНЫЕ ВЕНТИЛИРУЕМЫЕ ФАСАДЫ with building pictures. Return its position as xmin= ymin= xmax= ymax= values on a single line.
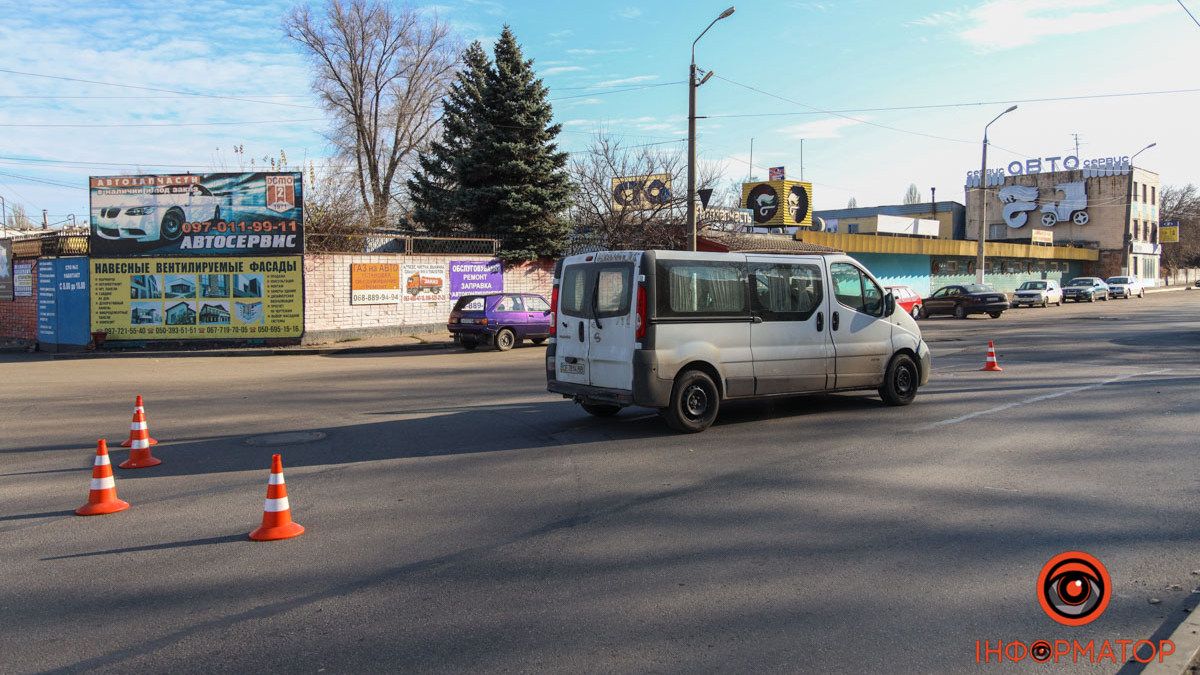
xmin=91 ymin=256 xmax=304 ymax=340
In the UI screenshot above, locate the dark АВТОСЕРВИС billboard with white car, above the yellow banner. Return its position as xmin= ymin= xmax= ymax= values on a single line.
xmin=89 ymin=172 xmax=304 ymax=257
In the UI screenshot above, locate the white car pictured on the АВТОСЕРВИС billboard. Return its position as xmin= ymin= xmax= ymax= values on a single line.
xmin=91 ymin=185 xmax=222 ymax=241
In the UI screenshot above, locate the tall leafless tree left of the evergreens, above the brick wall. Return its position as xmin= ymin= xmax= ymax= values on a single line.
xmin=283 ymin=0 xmax=458 ymax=227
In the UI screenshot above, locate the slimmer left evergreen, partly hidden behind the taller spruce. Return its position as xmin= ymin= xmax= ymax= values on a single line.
xmin=408 ymin=42 xmax=492 ymax=232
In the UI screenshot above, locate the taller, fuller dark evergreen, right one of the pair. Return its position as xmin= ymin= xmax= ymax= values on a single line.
xmin=468 ymin=26 xmax=571 ymax=259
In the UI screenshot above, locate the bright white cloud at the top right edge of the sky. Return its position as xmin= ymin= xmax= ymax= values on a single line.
xmin=907 ymin=0 xmax=1178 ymax=52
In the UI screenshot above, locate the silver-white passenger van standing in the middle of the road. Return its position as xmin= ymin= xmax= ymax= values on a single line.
xmin=546 ymin=251 xmax=931 ymax=432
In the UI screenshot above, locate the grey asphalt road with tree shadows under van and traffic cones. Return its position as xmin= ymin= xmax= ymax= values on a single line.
xmin=0 ymin=292 xmax=1200 ymax=673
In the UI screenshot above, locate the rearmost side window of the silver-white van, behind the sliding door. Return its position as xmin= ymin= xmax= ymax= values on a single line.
xmin=656 ymin=261 xmax=748 ymax=317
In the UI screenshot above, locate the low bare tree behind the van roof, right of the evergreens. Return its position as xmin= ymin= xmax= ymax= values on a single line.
xmin=568 ymin=135 xmax=719 ymax=250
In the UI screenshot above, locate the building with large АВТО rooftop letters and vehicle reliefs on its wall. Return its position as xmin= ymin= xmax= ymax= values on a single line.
xmin=966 ymin=156 xmax=1162 ymax=286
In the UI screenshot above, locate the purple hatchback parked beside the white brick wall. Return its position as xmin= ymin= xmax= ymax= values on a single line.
xmin=446 ymin=293 xmax=551 ymax=352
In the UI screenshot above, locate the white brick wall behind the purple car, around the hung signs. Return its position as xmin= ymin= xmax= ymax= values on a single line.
xmin=304 ymin=253 xmax=553 ymax=344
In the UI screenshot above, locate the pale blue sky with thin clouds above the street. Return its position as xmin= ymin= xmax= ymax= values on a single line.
xmin=0 ymin=0 xmax=1200 ymax=222
